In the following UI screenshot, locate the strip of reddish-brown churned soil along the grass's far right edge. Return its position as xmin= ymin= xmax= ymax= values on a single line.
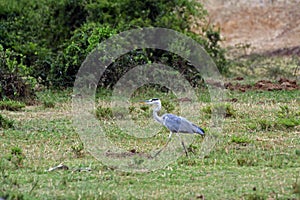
xmin=224 ymin=77 xmax=300 ymax=92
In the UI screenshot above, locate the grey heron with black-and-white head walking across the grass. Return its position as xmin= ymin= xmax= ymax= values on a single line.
xmin=141 ymin=98 xmax=205 ymax=157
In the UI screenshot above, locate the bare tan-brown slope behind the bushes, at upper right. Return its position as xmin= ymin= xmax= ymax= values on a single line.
xmin=195 ymin=0 xmax=300 ymax=56
